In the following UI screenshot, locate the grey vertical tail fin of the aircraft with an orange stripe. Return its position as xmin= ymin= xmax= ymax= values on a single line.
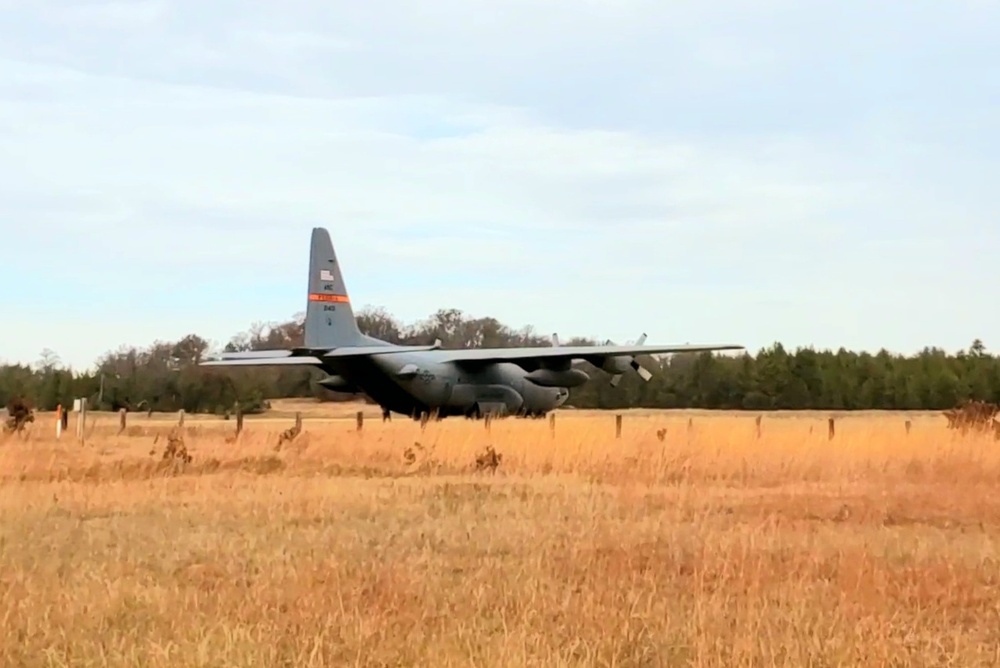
xmin=304 ymin=227 xmax=362 ymax=348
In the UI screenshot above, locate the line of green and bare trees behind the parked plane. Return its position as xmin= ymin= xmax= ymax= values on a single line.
xmin=0 ymin=308 xmax=1000 ymax=414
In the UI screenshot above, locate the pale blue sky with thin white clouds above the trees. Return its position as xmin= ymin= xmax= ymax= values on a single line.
xmin=0 ymin=0 xmax=1000 ymax=368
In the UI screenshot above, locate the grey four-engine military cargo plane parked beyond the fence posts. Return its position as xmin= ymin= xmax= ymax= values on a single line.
xmin=201 ymin=227 xmax=743 ymax=418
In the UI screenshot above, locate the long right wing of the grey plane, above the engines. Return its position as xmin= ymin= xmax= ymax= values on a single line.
xmin=437 ymin=343 xmax=744 ymax=368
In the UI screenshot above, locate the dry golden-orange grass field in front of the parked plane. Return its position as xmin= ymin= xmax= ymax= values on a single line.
xmin=0 ymin=404 xmax=1000 ymax=668
